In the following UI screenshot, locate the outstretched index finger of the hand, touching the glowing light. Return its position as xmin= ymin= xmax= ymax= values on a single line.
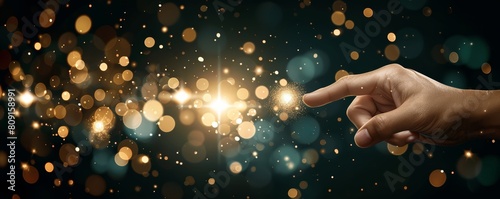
xmin=302 ymin=67 xmax=381 ymax=107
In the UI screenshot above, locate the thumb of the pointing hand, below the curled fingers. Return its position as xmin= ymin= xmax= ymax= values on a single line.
xmin=354 ymin=105 xmax=416 ymax=148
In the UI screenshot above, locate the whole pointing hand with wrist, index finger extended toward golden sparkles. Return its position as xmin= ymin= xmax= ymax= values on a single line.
xmin=302 ymin=64 xmax=500 ymax=148
